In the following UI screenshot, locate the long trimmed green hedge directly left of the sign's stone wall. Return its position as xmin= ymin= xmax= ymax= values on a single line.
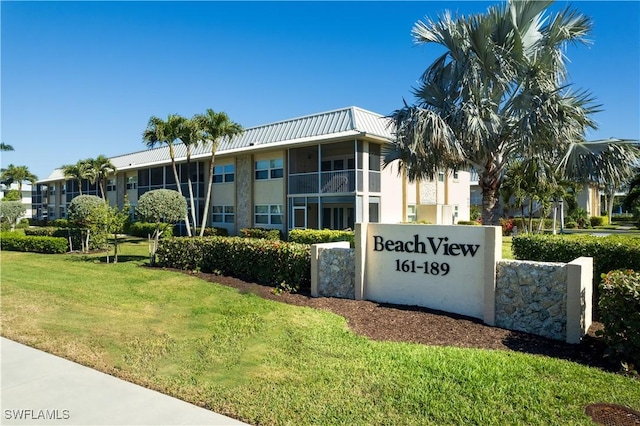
xmin=156 ymin=237 xmax=311 ymax=290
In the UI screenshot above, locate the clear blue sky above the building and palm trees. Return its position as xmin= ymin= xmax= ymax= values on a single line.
xmin=0 ymin=1 xmax=640 ymax=179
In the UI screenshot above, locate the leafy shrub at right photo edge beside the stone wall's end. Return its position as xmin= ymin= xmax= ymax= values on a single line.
xmin=598 ymin=270 xmax=640 ymax=367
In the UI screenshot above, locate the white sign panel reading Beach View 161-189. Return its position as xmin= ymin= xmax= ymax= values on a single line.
xmin=364 ymin=224 xmax=496 ymax=319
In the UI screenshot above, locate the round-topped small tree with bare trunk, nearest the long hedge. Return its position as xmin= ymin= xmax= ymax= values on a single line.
xmin=136 ymin=189 xmax=187 ymax=265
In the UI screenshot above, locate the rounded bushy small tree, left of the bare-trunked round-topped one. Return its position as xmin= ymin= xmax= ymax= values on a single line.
xmin=69 ymin=195 xmax=109 ymax=253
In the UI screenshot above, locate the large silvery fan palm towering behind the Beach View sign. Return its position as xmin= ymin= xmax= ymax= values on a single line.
xmin=384 ymin=0 xmax=597 ymax=225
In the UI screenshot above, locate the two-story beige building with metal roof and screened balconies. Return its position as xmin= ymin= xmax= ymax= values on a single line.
xmin=33 ymin=107 xmax=469 ymax=235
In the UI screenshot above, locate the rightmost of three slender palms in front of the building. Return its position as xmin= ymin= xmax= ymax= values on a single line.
xmin=195 ymin=108 xmax=244 ymax=237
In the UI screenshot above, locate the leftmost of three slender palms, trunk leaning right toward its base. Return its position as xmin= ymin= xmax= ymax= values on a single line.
xmin=142 ymin=114 xmax=191 ymax=236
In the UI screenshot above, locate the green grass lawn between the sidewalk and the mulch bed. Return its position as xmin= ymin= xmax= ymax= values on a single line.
xmin=0 ymin=243 xmax=640 ymax=425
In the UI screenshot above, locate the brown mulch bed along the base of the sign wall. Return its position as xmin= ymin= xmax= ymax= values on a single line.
xmin=190 ymin=273 xmax=617 ymax=370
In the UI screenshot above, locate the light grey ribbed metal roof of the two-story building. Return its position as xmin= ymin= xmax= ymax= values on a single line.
xmin=39 ymin=106 xmax=393 ymax=182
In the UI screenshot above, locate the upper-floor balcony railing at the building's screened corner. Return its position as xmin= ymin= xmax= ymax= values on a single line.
xmin=289 ymin=170 xmax=356 ymax=194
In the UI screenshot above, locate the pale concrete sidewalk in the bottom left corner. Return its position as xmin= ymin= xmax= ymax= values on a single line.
xmin=0 ymin=338 xmax=251 ymax=426
